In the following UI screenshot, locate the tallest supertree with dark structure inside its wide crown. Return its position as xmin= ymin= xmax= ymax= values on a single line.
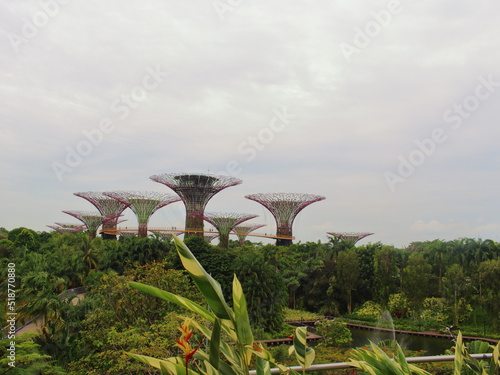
xmin=150 ymin=173 xmax=242 ymax=237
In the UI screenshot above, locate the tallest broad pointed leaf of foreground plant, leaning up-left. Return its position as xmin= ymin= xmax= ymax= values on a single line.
xmin=174 ymin=235 xmax=233 ymax=320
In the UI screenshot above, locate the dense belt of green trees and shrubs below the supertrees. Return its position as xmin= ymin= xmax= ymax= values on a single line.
xmin=0 ymin=228 xmax=500 ymax=374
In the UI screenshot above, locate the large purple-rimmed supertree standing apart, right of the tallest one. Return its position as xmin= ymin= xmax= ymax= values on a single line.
xmin=245 ymin=193 xmax=325 ymax=246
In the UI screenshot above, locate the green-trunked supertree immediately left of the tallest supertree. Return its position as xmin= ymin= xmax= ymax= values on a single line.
xmin=103 ymin=191 xmax=181 ymax=237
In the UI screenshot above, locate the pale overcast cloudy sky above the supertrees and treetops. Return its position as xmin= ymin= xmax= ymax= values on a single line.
xmin=0 ymin=0 xmax=500 ymax=247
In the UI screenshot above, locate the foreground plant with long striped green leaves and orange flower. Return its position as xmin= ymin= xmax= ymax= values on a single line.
xmin=127 ymin=236 xmax=314 ymax=375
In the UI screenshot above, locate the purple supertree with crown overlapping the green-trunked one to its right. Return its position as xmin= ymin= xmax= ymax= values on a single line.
xmin=73 ymin=191 xmax=128 ymax=239
